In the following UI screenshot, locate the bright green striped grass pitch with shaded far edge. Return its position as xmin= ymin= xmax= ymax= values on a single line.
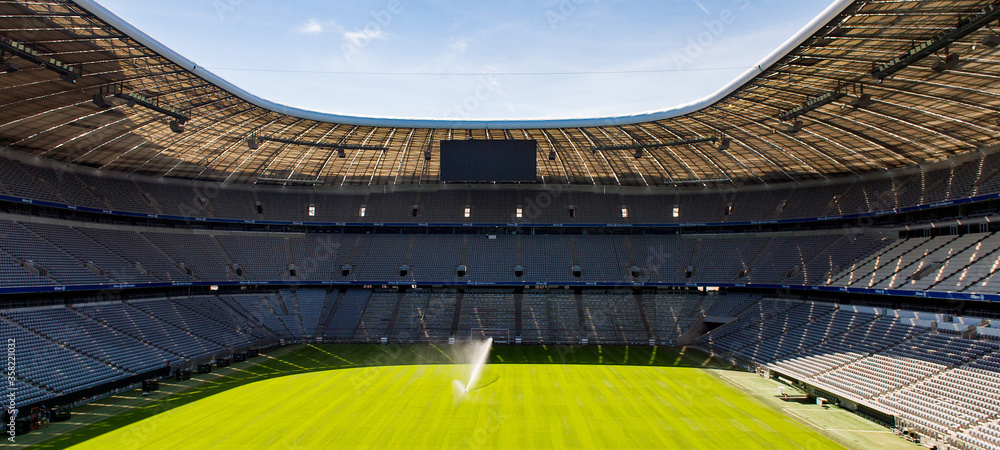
xmin=60 ymin=345 xmax=842 ymax=450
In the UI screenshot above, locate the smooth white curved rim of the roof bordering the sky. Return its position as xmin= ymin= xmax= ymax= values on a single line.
xmin=74 ymin=0 xmax=854 ymax=129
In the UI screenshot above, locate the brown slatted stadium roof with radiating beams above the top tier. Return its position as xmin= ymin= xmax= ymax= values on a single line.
xmin=0 ymin=0 xmax=1000 ymax=186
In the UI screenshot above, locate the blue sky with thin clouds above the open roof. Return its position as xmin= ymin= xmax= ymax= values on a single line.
xmin=99 ymin=0 xmax=830 ymax=119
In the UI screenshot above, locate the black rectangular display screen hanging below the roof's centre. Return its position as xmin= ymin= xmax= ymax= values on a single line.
xmin=441 ymin=139 xmax=538 ymax=183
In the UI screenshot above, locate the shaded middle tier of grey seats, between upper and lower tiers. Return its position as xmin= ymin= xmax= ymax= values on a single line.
xmin=0 ymin=215 xmax=900 ymax=286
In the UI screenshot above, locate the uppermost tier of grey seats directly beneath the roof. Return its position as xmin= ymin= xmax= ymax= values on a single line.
xmin=0 ymin=149 xmax=1000 ymax=227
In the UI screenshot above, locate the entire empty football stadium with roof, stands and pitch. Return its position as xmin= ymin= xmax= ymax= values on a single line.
xmin=0 ymin=0 xmax=1000 ymax=450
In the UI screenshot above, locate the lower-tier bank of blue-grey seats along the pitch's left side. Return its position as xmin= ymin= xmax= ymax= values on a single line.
xmin=0 ymin=297 xmax=276 ymax=405
